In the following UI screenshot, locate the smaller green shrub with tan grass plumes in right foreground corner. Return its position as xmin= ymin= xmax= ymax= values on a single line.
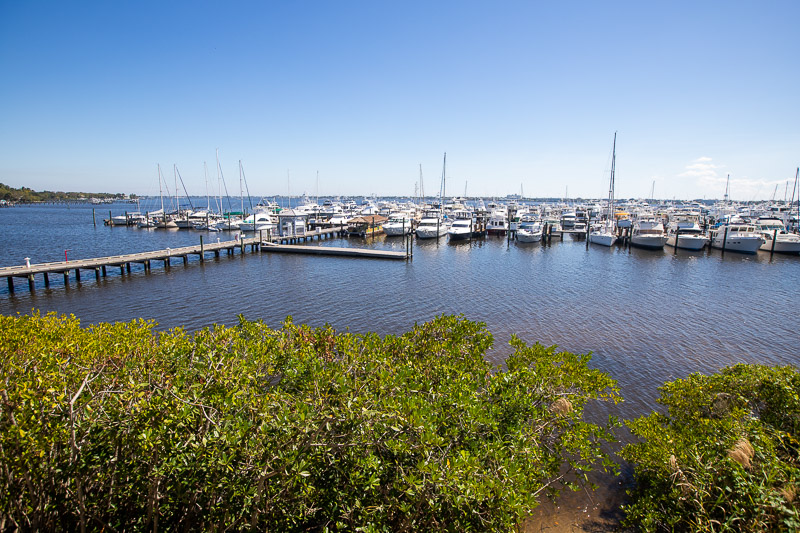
xmin=622 ymin=364 xmax=800 ymax=531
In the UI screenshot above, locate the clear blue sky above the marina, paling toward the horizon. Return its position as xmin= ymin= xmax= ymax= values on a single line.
xmin=0 ymin=0 xmax=800 ymax=200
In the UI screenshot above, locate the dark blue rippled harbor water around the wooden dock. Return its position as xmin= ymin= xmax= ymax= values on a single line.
xmin=0 ymin=204 xmax=800 ymax=528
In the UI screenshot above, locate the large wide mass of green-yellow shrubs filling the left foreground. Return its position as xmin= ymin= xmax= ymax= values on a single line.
xmin=0 ymin=314 xmax=619 ymax=531
